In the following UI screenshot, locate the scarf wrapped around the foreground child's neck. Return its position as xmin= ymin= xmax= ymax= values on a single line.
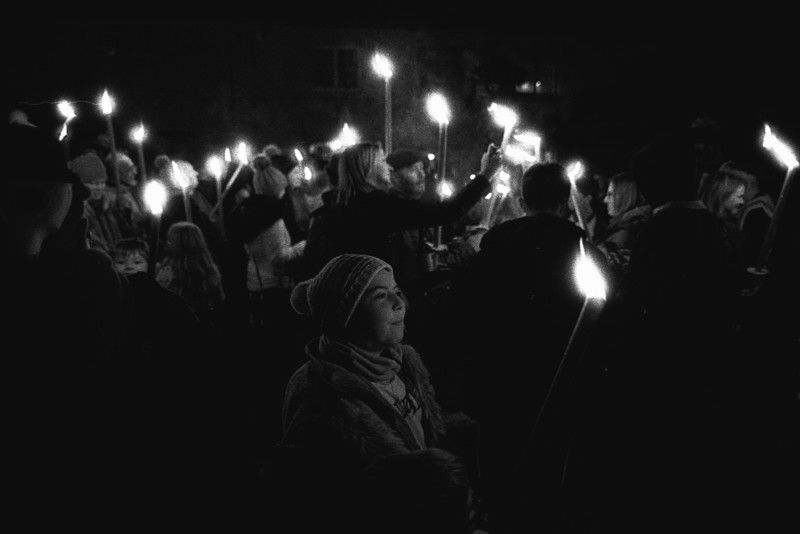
xmin=319 ymin=335 xmax=403 ymax=383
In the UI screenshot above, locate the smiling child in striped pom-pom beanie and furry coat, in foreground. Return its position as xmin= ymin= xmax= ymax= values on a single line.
xmin=271 ymin=254 xmax=472 ymax=534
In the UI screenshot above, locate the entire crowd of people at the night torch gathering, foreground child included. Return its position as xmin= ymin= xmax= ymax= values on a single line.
xmin=0 ymin=105 xmax=800 ymax=534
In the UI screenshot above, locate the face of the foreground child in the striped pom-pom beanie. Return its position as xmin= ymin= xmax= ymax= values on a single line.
xmin=347 ymin=270 xmax=406 ymax=351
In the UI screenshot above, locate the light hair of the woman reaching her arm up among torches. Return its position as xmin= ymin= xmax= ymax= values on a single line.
xmin=336 ymin=143 xmax=388 ymax=204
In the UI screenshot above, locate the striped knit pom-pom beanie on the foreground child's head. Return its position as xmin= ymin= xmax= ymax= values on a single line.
xmin=291 ymin=254 xmax=392 ymax=335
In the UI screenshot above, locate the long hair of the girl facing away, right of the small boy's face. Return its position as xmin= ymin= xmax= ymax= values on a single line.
xmin=159 ymin=221 xmax=224 ymax=303
